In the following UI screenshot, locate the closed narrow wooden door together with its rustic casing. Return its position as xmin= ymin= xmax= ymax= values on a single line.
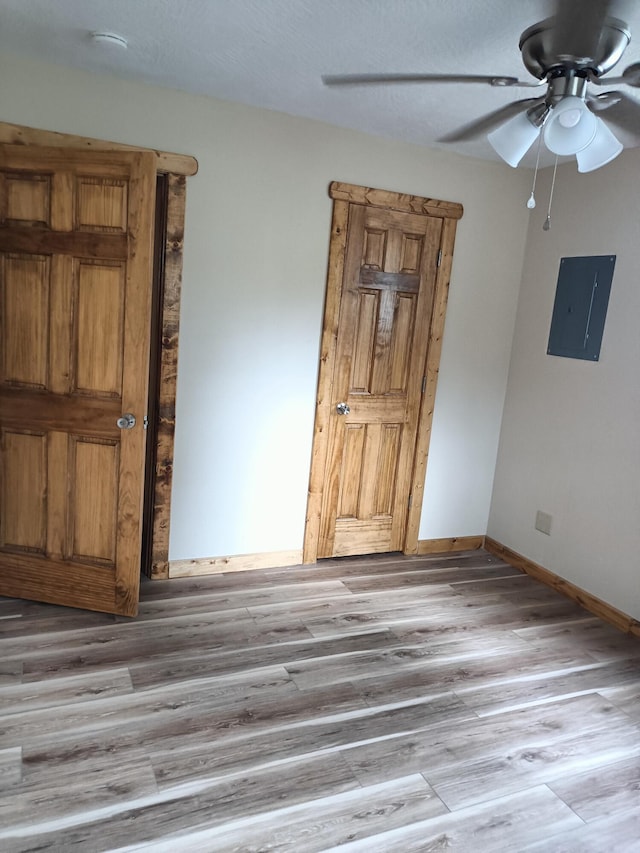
xmin=304 ymin=184 xmax=462 ymax=562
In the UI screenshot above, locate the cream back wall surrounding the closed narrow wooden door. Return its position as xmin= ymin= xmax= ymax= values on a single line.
xmin=0 ymin=51 xmax=530 ymax=559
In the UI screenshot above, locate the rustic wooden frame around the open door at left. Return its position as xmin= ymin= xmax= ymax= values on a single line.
xmin=0 ymin=122 xmax=198 ymax=579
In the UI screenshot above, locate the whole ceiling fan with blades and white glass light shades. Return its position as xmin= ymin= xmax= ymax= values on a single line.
xmin=322 ymin=0 xmax=640 ymax=172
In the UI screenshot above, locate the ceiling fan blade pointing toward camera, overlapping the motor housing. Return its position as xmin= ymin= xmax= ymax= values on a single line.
xmin=553 ymin=0 xmax=612 ymax=58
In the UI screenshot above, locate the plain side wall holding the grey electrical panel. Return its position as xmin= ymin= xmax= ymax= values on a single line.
xmin=488 ymin=149 xmax=640 ymax=618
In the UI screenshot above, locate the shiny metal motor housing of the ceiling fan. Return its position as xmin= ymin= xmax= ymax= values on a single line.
xmin=520 ymin=18 xmax=631 ymax=80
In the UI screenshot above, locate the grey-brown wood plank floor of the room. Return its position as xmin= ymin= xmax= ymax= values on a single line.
xmin=0 ymin=551 xmax=640 ymax=853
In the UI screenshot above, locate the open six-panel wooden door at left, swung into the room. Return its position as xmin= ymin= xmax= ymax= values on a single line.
xmin=0 ymin=145 xmax=156 ymax=615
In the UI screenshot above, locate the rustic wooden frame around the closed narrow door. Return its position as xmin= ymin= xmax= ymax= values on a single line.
xmin=302 ymin=181 xmax=463 ymax=564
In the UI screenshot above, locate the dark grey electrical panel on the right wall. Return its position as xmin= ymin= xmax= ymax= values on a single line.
xmin=547 ymin=255 xmax=616 ymax=361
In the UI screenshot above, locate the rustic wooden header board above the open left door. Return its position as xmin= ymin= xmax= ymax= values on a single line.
xmin=0 ymin=121 xmax=198 ymax=176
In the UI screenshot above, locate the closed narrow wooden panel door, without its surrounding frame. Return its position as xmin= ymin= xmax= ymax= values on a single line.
xmin=318 ymin=204 xmax=442 ymax=557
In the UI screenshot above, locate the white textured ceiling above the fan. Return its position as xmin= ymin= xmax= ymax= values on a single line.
xmin=0 ymin=0 xmax=640 ymax=165
